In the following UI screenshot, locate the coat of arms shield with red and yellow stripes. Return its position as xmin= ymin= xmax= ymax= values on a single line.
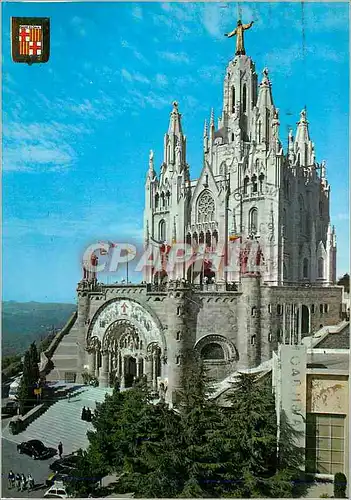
xmin=11 ymin=17 xmax=50 ymax=64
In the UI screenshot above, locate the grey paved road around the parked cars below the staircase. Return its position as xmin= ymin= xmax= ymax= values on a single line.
xmin=1 ymin=426 xmax=58 ymax=498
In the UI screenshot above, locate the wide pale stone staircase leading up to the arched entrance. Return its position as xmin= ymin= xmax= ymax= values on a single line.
xmin=2 ymin=386 xmax=112 ymax=455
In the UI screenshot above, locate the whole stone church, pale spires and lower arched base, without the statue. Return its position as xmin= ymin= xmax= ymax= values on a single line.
xmin=43 ymin=46 xmax=342 ymax=402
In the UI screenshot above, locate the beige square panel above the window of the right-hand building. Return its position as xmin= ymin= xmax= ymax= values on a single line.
xmin=310 ymin=378 xmax=348 ymax=414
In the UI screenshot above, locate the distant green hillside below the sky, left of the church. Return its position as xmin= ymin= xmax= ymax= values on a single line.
xmin=2 ymin=301 xmax=77 ymax=356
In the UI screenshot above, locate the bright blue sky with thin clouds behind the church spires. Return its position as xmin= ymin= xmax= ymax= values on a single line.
xmin=1 ymin=2 xmax=349 ymax=302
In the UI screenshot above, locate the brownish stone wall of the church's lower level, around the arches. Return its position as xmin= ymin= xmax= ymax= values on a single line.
xmin=48 ymin=282 xmax=342 ymax=394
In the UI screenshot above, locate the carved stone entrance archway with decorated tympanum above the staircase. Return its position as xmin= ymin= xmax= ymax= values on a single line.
xmin=86 ymin=299 xmax=166 ymax=390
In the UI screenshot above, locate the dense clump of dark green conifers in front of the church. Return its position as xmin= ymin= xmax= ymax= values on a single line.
xmin=72 ymin=352 xmax=301 ymax=498
